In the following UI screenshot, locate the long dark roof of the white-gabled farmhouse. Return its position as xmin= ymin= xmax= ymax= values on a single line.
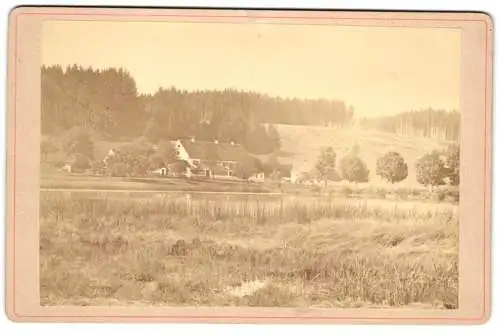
xmin=181 ymin=140 xmax=247 ymax=161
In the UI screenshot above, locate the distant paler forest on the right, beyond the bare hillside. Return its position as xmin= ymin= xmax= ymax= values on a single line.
xmin=360 ymin=108 xmax=460 ymax=141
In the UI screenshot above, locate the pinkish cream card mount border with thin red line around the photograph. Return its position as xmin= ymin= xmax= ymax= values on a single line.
xmin=6 ymin=7 xmax=493 ymax=324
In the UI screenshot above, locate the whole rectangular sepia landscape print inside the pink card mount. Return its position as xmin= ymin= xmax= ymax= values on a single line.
xmin=39 ymin=18 xmax=462 ymax=310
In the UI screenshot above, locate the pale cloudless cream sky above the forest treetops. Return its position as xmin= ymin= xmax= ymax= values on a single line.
xmin=41 ymin=21 xmax=460 ymax=117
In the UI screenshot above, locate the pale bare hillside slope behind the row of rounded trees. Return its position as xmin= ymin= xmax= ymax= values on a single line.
xmin=275 ymin=125 xmax=458 ymax=185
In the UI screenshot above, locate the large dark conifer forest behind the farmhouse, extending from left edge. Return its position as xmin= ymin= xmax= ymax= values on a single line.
xmin=41 ymin=65 xmax=354 ymax=153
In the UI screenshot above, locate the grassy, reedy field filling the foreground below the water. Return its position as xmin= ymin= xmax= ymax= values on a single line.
xmin=40 ymin=192 xmax=458 ymax=308
